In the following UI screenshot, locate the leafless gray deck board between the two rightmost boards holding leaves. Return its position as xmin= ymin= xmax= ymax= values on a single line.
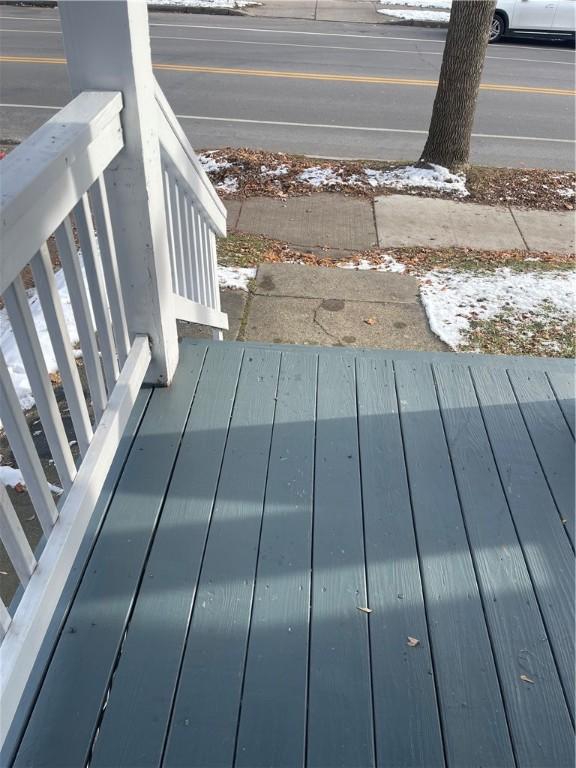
xmin=395 ymin=361 xmax=514 ymax=768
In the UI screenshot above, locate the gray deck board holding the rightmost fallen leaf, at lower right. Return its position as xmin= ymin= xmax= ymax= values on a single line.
xmin=434 ymin=365 xmax=574 ymax=768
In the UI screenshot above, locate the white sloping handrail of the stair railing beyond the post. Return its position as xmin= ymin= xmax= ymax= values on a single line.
xmin=155 ymin=81 xmax=226 ymax=237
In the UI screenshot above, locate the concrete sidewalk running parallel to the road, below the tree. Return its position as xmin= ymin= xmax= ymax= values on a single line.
xmin=226 ymin=193 xmax=575 ymax=258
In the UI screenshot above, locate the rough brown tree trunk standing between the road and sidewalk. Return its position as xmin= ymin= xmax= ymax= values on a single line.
xmin=420 ymin=0 xmax=496 ymax=170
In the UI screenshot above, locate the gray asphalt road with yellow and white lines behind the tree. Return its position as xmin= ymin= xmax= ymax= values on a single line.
xmin=0 ymin=7 xmax=575 ymax=169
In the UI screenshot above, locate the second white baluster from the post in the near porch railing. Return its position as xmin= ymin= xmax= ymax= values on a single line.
xmin=74 ymin=195 xmax=119 ymax=394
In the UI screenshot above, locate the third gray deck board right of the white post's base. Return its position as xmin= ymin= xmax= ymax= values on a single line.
xmin=164 ymin=350 xmax=280 ymax=768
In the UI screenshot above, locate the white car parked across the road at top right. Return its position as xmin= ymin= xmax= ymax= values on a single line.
xmin=490 ymin=0 xmax=576 ymax=43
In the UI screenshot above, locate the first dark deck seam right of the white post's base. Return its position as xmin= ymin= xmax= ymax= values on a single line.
xmin=84 ymin=349 xmax=208 ymax=766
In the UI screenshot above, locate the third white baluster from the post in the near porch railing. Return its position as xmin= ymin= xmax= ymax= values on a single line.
xmin=56 ymin=219 xmax=107 ymax=424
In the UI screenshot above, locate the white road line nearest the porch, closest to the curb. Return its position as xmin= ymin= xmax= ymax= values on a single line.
xmin=0 ymin=103 xmax=576 ymax=144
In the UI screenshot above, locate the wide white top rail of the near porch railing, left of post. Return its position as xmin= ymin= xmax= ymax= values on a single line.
xmin=0 ymin=91 xmax=123 ymax=293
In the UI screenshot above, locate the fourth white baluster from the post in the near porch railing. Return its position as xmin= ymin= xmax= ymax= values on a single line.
xmin=30 ymin=245 xmax=92 ymax=456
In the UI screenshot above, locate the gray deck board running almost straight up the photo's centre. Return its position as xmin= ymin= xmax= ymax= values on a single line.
xmin=307 ymin=355 xmax=375 ymax=768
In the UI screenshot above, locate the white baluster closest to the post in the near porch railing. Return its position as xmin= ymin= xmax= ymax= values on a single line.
xmin=90 ymin=176 xmax=130 ymax=368
